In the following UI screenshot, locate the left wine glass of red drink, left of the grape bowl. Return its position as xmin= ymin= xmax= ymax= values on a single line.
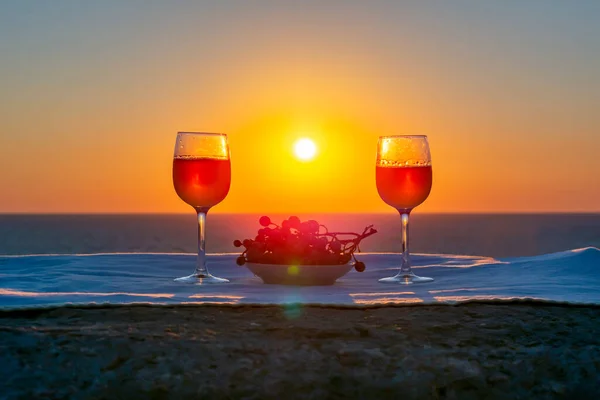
xmin=173 ymin=132 xmax=231 ymax=284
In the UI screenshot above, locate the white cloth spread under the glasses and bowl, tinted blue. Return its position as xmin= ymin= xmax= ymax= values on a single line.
xmin=0 ymin=248 xmax=600 ymax=309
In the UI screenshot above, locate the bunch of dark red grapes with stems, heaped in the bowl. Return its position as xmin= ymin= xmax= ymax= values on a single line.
xmin=233 ymin=216 xmax=377 ymax=272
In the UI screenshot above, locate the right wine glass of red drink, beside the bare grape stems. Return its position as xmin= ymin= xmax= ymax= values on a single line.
xmin=375 ymin=135 xmax=433 ymax=285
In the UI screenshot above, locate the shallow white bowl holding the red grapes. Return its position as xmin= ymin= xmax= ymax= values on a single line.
xmin=245 ymin=261 xmax=354 ymax=286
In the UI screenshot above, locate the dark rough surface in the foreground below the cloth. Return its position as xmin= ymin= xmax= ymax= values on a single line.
xmin=0 ymin=304 xmax=600 ymax=399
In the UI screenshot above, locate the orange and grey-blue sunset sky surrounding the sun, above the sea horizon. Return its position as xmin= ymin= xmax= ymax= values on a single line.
xmin=0 ymin=0 xmax=600 ymax=213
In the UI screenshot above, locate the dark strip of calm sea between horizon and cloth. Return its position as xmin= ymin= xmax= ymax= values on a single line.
xmin=0 ymin=212 xmax=600 ymax=257
